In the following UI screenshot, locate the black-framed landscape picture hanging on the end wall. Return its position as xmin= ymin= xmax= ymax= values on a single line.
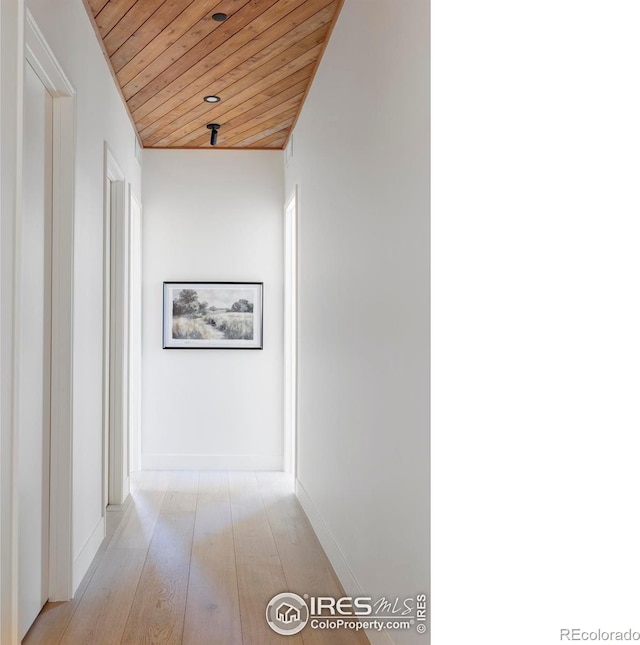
xmin=162 ymin=282 xmax=263 ymax=349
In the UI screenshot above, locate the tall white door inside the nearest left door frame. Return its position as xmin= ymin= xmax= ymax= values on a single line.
xmin=16 ymin=56 xmax=53 ymax=638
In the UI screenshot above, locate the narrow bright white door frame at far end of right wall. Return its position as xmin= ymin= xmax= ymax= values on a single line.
xmin=284 ymin=186 xmax=298 ymax=477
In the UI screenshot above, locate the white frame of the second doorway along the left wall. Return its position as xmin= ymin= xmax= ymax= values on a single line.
xmin=102 ymin=142 xmax=129 ymax=514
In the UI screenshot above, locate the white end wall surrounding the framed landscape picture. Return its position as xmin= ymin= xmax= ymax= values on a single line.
xmin=142 ymin=150 xmax=284 ymax=469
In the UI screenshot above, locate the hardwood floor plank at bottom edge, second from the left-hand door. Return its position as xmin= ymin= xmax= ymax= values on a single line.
xmin=60 ymin=549 xmax=147 ymax=645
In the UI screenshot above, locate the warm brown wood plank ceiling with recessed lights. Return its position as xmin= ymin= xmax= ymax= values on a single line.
xmin=84 ymin=0 xmax=342 ymax=149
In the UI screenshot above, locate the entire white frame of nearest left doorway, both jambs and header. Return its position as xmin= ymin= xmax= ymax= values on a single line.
xmin=0 ymin=8 xmax=75 ymax=632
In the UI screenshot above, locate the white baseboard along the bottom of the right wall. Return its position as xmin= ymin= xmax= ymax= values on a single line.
xmin=296 ymin=479 xmax=393 ymax=645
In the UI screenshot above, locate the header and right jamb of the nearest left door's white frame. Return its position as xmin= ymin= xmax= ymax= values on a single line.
xmin=24 ymin=10 xmax=75 ymax=600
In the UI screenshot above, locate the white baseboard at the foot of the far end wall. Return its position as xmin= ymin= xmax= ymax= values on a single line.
xmin=142 ymin=455 xmax=284 ymax=470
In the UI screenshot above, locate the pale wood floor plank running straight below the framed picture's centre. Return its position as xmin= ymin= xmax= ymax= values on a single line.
xmin=182 ymin=472 xmax=243 ymax=645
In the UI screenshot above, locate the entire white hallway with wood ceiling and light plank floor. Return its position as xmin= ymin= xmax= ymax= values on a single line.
xmin=0 ymin=0 xmax=430 ymax=645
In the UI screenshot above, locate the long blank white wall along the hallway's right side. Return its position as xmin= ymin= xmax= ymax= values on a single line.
xmin=285 ymin=0 xmax=429 ymax=644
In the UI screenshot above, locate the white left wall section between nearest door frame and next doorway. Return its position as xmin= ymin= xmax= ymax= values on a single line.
xmin=21 ymin=0 xmax=141 ymax=586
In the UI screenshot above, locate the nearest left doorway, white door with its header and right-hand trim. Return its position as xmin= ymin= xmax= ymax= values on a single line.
xmin=11 ymin=11 xmax=75 ymax=638
